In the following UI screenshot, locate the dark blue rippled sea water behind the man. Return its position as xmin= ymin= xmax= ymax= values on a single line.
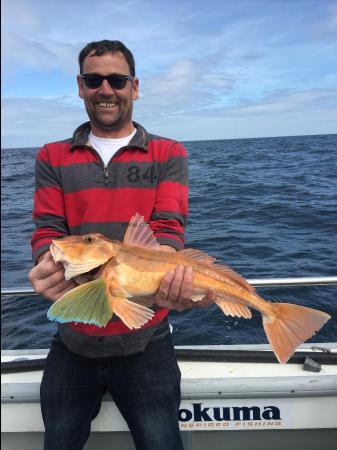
xmin=1 ymin=134 xmax=337 ymax=349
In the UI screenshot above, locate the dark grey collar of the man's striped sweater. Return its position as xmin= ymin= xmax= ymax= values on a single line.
xmin=70 ymin=122 xmax=150 ymax=152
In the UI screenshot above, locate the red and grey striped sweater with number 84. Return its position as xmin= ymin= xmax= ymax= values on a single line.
xmin=32 ymin=122 xmax=188 ymax=354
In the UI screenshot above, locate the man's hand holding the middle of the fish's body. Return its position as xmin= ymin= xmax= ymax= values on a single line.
xmin=156 ymin=266 xmax=215 ymax=311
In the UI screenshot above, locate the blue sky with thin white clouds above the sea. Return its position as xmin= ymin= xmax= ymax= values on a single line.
xmin=1 ymin=0 xmax=337 ymax=148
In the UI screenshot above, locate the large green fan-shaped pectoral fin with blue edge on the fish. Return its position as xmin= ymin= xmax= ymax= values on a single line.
xmin=47 ymin=278 xmax=112 ymax=327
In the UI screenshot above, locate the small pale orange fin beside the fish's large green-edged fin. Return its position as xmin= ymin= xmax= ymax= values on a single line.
xmin=109 ymin=295 xmax=154 ymax=329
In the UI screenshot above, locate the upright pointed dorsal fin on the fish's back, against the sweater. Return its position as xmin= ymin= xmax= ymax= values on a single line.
xmin=123 ymin=213 xmax=160 ymax=250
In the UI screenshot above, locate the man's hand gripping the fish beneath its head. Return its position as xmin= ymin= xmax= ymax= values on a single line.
xmin=28 ymin=251 xmax=77 ymax=301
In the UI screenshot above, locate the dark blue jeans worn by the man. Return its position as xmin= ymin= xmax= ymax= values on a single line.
xmin=41 ymin=324 xmax=183 ymax=450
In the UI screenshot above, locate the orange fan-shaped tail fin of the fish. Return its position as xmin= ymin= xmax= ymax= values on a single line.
xmin=262 ymin=303 xmax=330 ymax=363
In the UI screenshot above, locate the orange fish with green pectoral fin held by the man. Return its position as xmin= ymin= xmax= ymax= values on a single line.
xmin=47 ymin=213 xmax=330 ymax=363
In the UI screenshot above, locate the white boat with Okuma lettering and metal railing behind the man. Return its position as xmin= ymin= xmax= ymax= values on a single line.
xmin=1 ymin=277 xmax=337 ymax=450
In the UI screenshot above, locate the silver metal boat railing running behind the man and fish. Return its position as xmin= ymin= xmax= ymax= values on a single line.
xmin=1 ymin=277 xmax=337 ymax=297
